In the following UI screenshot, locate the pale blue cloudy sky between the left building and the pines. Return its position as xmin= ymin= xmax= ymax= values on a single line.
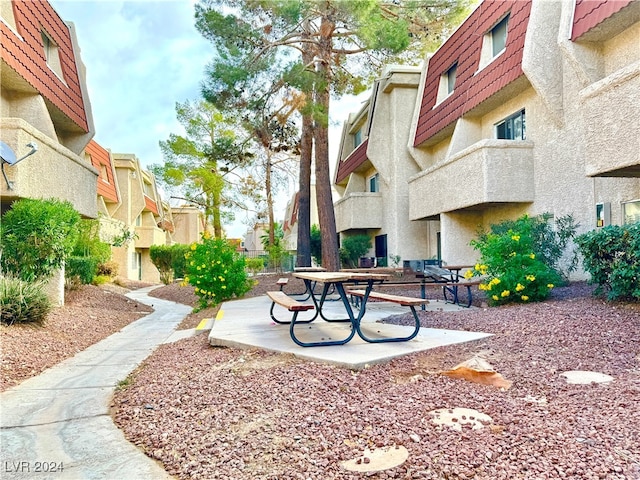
xmin=49 ymin=0 xmax=366 ymax=237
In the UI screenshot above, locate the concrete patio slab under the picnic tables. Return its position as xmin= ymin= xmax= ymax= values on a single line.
xmin=209 ymin=296 xmax=490 ymax=370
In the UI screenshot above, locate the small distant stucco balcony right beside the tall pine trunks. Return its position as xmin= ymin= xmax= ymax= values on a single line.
xmin=334 ymin=192 xmax=383 ymax=232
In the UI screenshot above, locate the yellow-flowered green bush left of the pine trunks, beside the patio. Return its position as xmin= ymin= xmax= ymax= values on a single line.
xmin=182 ymin=235 xmax=253 ymax=308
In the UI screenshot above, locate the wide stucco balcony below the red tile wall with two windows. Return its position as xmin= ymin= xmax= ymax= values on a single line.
xmin=409 ymin=139 xmax=535 ymax=220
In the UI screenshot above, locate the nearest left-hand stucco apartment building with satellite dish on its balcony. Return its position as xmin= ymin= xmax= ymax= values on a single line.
xmin=0 ymin=0 xmax=98 ymax=304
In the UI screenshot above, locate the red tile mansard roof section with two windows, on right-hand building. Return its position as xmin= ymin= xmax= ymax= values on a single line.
xmin=414 ymin=0 xmax=531 ymax=146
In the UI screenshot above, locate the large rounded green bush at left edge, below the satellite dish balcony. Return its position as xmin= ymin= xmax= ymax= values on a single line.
xmin=0 ymin=199 xmax=80 ymax=281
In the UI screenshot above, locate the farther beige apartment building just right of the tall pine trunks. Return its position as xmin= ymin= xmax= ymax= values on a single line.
xmin=334 ymin=66 xmax=430 ymax=266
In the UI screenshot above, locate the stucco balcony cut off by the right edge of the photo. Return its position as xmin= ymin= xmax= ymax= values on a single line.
xmin=580 ymin=62 xmax=640 ymax=177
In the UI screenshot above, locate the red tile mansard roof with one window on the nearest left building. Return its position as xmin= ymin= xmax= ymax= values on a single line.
xmin=0 ymin=0 xmax=89 ymax=132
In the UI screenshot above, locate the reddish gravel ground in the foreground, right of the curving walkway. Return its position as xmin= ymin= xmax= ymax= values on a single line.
xmin=113 ymin=279 xmax=640 ymax=480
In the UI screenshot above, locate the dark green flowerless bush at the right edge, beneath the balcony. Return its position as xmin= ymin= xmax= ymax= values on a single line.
xmin=576 ymin=223 xmax=640 ymax=301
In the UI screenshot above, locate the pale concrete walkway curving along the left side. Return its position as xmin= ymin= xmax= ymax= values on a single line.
xmin=0 ymin=287 xmax=191 ymax=480
